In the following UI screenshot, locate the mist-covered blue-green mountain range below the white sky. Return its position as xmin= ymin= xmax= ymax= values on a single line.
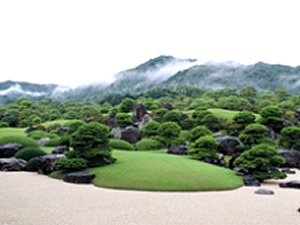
xmin=0 ymin=56 xmax=300 ymax=104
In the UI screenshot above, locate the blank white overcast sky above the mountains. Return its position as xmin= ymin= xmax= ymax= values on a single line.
xmin=0 ymin=0 xmax=300 ymax=86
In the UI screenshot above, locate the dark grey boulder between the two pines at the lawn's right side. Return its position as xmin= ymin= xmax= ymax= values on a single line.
xmin=216 ymin=136 xmax=243 ymax=156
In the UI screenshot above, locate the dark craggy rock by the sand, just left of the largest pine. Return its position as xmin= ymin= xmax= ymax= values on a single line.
xmin=36 ymin=154 xmax=66 ymax=175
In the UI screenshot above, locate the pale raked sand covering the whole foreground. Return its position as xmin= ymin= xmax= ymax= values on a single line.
xmin=0 ymin=170 xmax=300 ymax=225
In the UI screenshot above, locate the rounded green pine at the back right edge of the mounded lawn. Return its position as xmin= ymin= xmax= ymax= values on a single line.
xmin=188 ymin=135 xmax=219 ymax=160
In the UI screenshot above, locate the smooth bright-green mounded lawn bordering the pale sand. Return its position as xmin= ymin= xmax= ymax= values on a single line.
xmin=87 ymin=150 xmax=243 ymax=191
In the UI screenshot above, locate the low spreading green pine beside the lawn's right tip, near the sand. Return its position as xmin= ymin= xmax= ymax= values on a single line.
xmin=234 ymin=143 xmax=286 ymax=181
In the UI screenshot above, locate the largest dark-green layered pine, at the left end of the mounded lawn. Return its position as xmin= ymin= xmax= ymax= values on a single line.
xmin=71 ymin=122 xmax=115 ymax=166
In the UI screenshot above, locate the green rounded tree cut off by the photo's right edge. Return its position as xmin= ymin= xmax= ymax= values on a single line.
xmin=279 ymin=126 xmax=300 ymax=150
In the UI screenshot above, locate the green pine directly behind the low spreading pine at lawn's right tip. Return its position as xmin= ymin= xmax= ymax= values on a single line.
xmin=239 ymin=123 xmax=271 ymax=149
